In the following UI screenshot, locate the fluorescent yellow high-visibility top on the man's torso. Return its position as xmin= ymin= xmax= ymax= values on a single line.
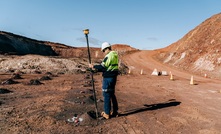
xmin=102 ymin=51 xmax=118 ymax=71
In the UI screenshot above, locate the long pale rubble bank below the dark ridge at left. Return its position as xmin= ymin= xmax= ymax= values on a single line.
xmin=0 ymin=55 xmax=85 ymax=74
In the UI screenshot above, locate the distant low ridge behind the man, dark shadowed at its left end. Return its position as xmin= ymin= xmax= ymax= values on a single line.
xmin=0 ymin=31 xmax=137 ymax=58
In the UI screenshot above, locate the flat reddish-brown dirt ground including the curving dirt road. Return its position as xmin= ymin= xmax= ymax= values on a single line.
xmin=0 ymin=51 xmax=221 ymax=134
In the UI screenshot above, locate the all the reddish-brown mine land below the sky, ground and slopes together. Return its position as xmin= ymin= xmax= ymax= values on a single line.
xmin=0 ymin=13 xmax=221 ymax=134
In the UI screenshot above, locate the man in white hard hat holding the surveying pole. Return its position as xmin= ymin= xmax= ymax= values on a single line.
xmin=89 ymin=42 xmax=118 ymax=119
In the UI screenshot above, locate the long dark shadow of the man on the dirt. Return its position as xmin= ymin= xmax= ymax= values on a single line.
xmin=119 ymin=99 xmax=181 ymax=116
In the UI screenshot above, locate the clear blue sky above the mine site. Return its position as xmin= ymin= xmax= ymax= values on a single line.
xmin=0 ymin=0 xmax=221 ymax=50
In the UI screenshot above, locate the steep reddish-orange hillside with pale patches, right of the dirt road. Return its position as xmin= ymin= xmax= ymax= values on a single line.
xmin=156 ymin=13 xmax=221 ymax=78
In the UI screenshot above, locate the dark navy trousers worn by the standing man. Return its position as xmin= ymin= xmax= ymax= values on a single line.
xmin=102 ymin=77 xmax=118 ymax=114
